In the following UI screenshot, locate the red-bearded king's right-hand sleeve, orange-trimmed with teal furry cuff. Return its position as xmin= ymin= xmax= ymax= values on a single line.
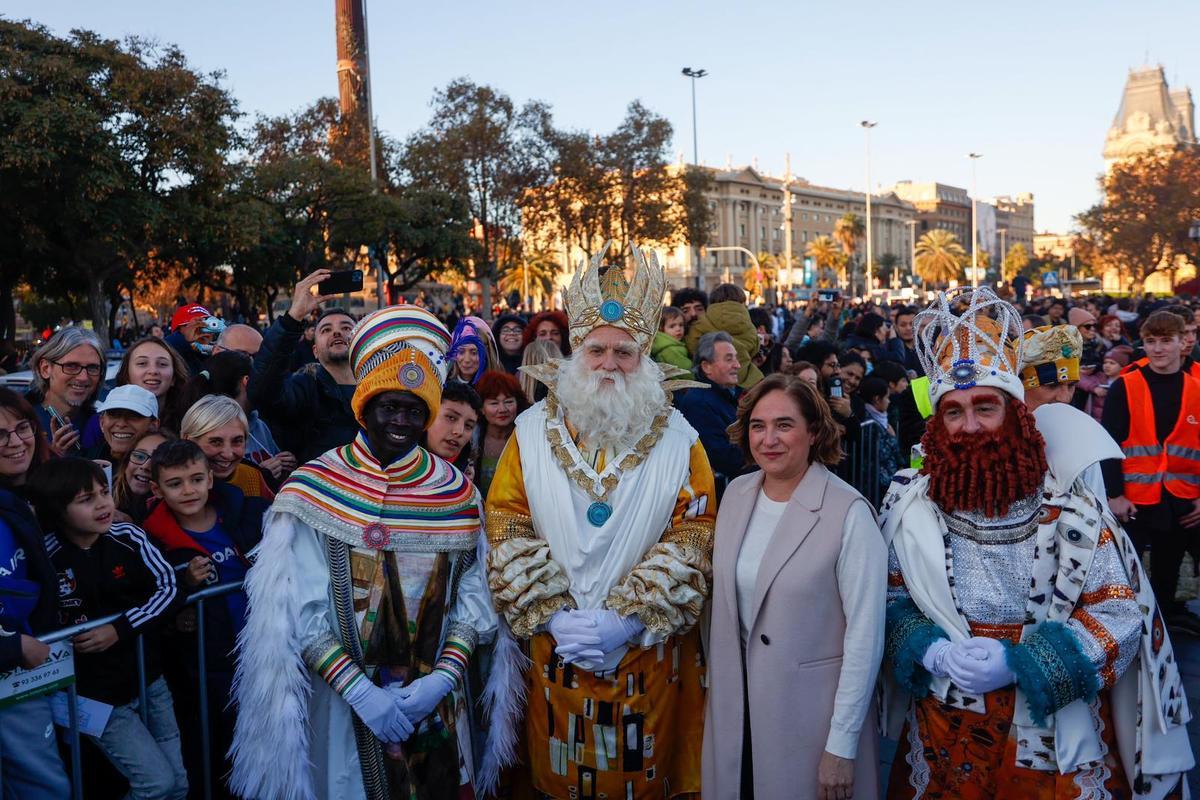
xmin=1008 ymin=529 xmax=1142 ymax=722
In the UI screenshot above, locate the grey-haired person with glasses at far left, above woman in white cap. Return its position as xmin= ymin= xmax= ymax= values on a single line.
xmin=25 ymin=325 xmax=104 ymax=456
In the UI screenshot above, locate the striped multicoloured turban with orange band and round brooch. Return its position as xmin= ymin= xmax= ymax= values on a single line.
xmin=350 ymin=306 xmax=450 ymax=427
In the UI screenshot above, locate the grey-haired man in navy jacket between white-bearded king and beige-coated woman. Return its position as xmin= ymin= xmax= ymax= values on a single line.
xmin=676 ymin=331 xmax=745 ymax=500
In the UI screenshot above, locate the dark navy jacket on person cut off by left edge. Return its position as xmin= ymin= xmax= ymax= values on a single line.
xmin=0 ymin=489 xmax=59 ymax=672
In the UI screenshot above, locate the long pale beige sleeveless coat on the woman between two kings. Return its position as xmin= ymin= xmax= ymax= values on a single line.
xmin=702 ymin=464 xmax=880 ymax=800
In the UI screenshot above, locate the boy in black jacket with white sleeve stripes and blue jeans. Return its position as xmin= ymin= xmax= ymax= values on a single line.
xmin=29 ymin=458 xmax=187 ymax=799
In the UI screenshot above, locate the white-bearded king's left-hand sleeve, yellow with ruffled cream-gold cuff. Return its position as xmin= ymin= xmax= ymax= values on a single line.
xmin=485 ymin=437 xmax=575 ymax=638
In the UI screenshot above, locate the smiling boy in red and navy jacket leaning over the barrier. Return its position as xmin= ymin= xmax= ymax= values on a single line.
xmin=145 ymin=439 xmax=268 ymax=795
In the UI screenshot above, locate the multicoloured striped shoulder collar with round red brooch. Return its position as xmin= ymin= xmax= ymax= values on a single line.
xmin=272 ymin=432 xmax=480 ymax=553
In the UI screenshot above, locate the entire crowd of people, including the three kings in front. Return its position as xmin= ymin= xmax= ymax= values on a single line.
xmin=0 ymin=255 xmax=1200 ymax=800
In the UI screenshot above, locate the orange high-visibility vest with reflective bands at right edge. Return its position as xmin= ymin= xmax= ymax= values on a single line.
xmin=1121 ymin=369 xmax=1200 ymax=505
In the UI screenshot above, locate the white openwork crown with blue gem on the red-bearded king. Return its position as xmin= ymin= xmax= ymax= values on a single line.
xmin=913 ymin=287 xmax=1025 ymax=407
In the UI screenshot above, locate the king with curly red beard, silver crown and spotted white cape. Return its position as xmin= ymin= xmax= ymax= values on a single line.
xmin=881 ymin=288 xmax=1193 ymax=800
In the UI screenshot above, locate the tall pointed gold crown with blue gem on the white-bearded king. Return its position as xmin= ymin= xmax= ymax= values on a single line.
xmin=565 ymin=241 xmax=666 ymax=353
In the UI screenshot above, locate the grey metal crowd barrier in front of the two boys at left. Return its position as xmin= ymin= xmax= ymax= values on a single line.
xmin=37 ymin=578 xmax=242 ymax=800
